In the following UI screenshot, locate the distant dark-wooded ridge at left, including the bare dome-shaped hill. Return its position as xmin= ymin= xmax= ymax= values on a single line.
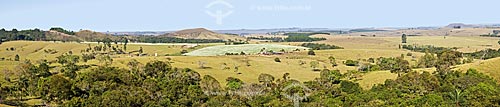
xmin=0 ymin=28 xmax=230 ymax=43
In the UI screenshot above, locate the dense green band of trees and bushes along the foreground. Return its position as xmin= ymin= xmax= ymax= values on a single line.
xmin=0 ymin=55 xmax=500 ymax=107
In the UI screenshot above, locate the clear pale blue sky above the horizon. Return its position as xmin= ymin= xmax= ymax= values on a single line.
xmin=0 ymin=0 xmax=500 ymax=32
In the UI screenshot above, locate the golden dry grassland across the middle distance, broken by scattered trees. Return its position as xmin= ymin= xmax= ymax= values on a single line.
xmin=0 ymin=35 xmax=500 ymax=89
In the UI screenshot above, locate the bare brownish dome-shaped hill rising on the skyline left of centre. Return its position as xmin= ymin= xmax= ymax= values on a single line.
xmin=161 ymin=28 xmax=245 ymax=40
